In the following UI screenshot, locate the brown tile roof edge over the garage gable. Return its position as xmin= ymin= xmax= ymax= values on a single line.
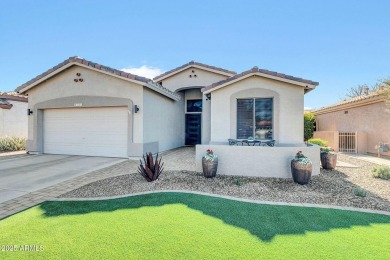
xmin=16 ymin=56 xmax=180 ymax=100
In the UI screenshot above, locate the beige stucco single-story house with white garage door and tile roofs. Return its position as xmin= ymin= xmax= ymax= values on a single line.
xmin=17 ymin=57 xmax=318 ymax=160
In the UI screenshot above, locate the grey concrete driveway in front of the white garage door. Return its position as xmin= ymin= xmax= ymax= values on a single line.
xmin=0 ymin=154 xmax=126 ymax=203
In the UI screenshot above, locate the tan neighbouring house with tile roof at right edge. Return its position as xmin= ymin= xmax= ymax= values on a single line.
xmin=313 ymin=91 xmax=390 ymax=156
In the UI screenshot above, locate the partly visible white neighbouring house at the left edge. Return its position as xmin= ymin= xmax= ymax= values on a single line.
xmin=0 ymin=92 xmax=28 ymax=137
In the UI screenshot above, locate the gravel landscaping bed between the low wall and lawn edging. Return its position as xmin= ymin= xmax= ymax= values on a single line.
xmin=60 ymin=148 xmax=390 ymax=211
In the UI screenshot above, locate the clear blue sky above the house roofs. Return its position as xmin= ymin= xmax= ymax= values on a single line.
xmin=0 ymin=0 xmax=390 ymax=108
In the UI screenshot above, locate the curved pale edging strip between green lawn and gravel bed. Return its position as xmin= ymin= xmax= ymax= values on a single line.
xmin=51 ymin=190 xmax=390 ymax=216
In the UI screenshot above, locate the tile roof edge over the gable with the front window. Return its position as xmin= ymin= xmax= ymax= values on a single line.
xmin=202 ymin=66 xmax=319 ymax=92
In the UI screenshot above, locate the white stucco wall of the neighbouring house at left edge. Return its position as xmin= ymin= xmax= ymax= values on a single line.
xmin=0 ymin=100 xmax=28 ymax=138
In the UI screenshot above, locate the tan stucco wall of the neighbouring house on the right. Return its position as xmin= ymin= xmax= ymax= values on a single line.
xmin=316 ymin=102 xmax=390 ymax=155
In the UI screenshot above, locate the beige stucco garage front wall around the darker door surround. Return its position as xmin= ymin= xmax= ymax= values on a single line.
xmin=27 ymin=66 xmax=143 ymax=155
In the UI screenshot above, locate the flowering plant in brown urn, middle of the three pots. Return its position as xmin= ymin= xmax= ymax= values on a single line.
xmin=291 ymin=151 xmax=313 ymax=184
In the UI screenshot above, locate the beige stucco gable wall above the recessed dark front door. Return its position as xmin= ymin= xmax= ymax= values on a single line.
xmin=162 ymin=68 xmax=227 ymax=91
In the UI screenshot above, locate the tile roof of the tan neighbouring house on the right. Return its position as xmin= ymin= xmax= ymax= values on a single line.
xmin=312 ymin=90 xmax=385 ymax=114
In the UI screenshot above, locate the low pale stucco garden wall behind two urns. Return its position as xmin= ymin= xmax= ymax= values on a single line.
xmin=196 ymin=145 xmax=320 ymax=178
